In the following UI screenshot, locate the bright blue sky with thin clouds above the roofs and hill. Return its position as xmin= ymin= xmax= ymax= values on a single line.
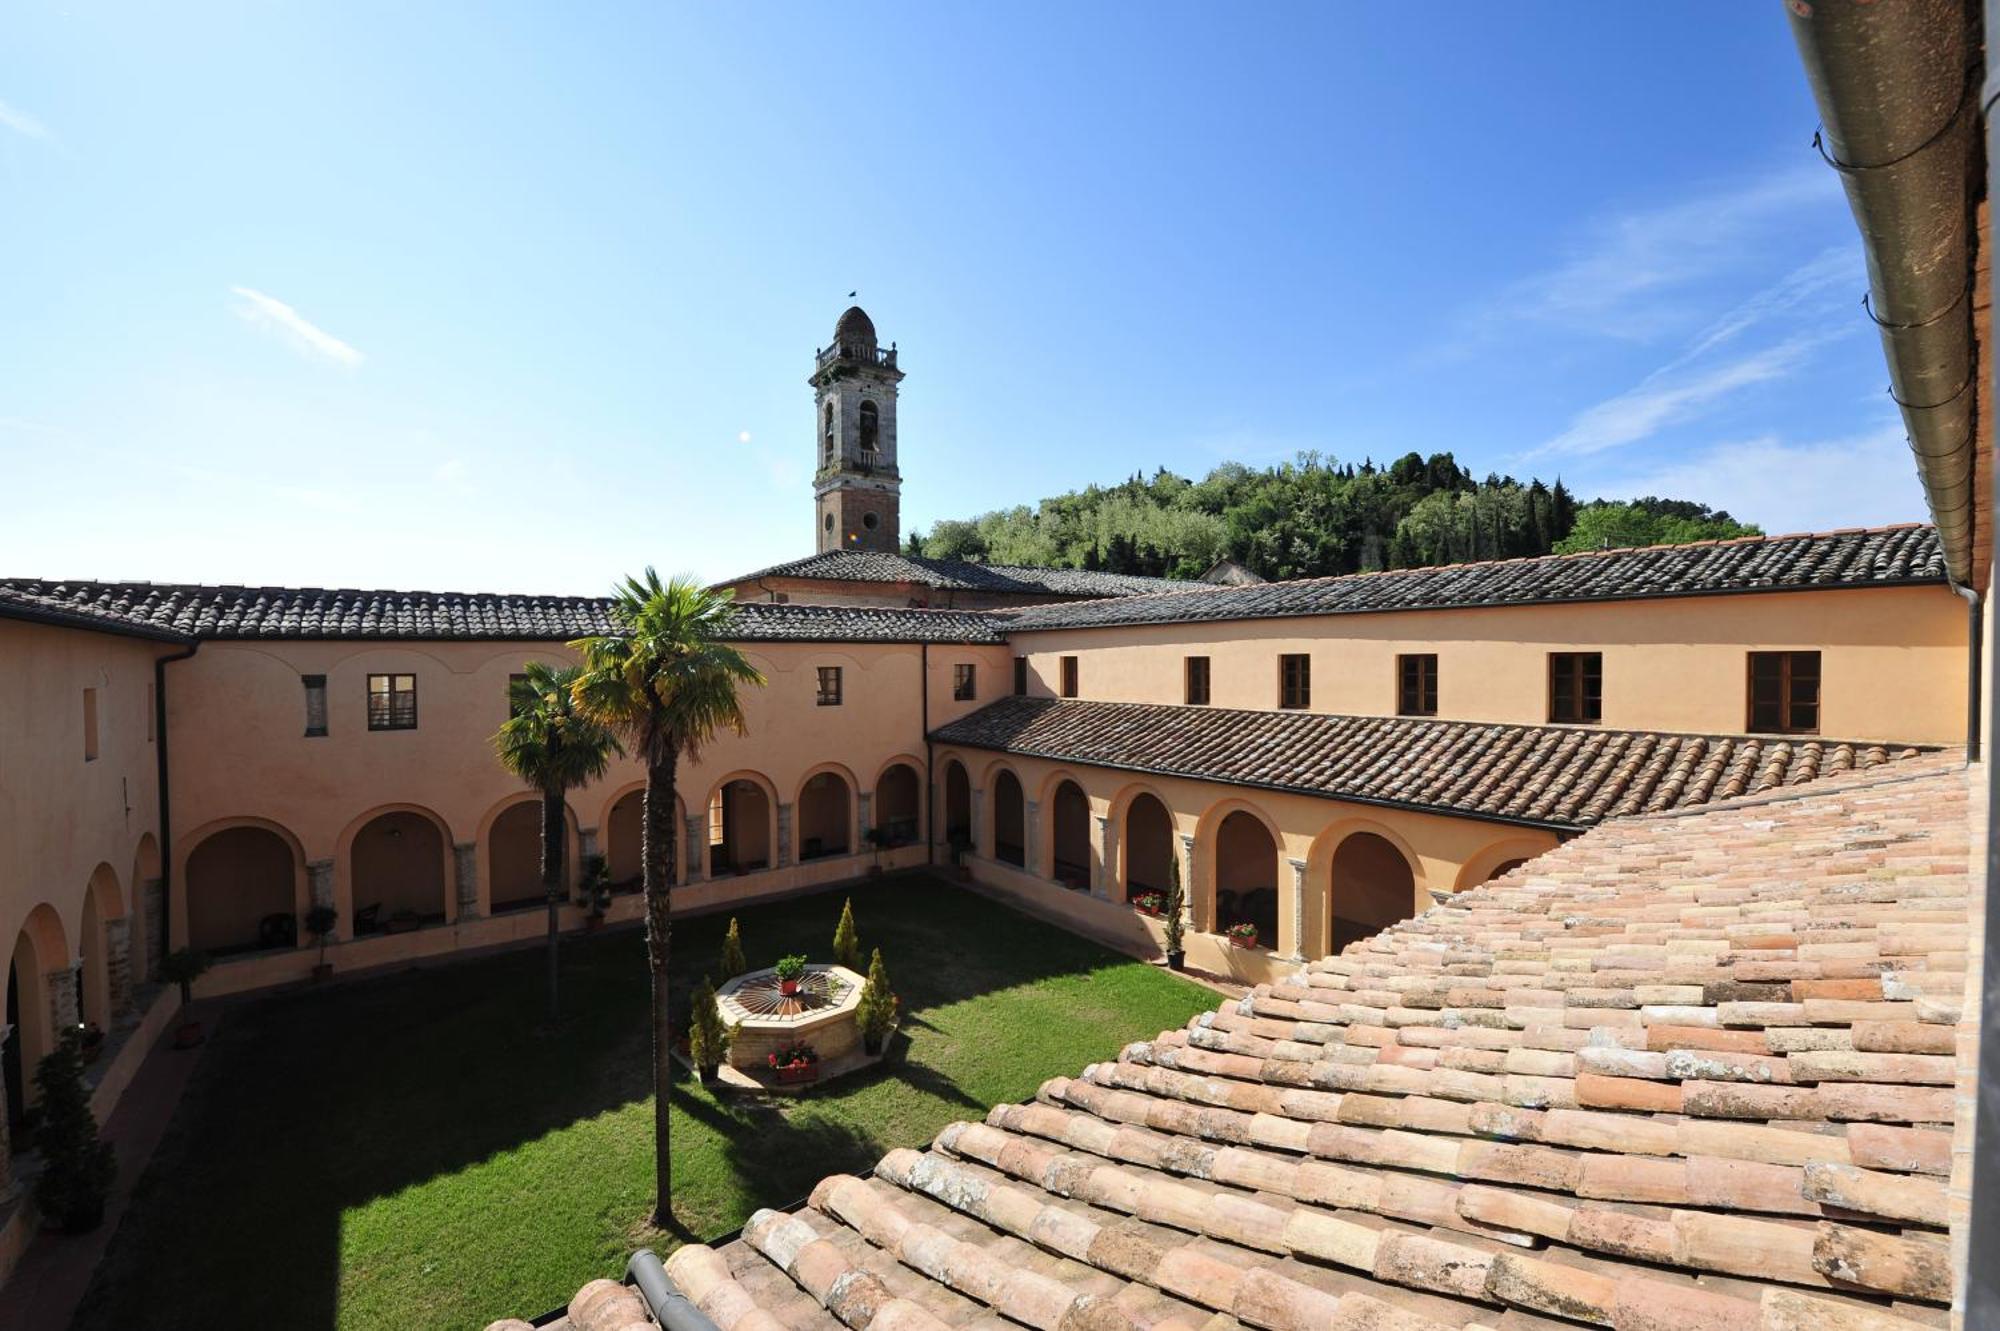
xmin=0 ymin=0 xmax=1922 ymax=592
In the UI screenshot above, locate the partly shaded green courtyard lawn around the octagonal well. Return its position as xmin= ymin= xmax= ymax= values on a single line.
xmin=76 ymin=873 xmax=1216 ymax=1331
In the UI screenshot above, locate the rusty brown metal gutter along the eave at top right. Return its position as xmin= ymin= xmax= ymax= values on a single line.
xmin=1786 ymin=0 xmax=1980 ymax=586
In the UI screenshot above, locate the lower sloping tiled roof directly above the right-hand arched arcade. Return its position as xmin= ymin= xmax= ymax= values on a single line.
xmin=932 ymin=697 xmax=1918 ymax=827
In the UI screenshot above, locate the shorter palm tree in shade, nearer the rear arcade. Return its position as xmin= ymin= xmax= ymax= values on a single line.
xmin=494 ymin=662 xmax=624 ymax=1021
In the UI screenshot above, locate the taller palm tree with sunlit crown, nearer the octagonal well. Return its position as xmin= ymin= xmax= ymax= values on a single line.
xmin=570 ymin=568 xmax=764 ymax=1229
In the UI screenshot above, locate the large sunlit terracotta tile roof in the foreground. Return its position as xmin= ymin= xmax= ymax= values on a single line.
xmin=498 ymin=759 xmax=1976 ymax=1331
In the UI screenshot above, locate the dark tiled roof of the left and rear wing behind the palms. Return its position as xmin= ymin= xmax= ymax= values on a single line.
xmin=0 ymin=578 xmax=1002 ymax=642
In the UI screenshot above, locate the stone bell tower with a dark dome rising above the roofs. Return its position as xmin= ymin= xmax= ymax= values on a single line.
xmin=806 ymin=306 xmax=902 ymax=554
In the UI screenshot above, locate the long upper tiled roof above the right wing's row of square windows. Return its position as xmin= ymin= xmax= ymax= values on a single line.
xmin=992 ymin=524 xmax=1944 ymax=630
